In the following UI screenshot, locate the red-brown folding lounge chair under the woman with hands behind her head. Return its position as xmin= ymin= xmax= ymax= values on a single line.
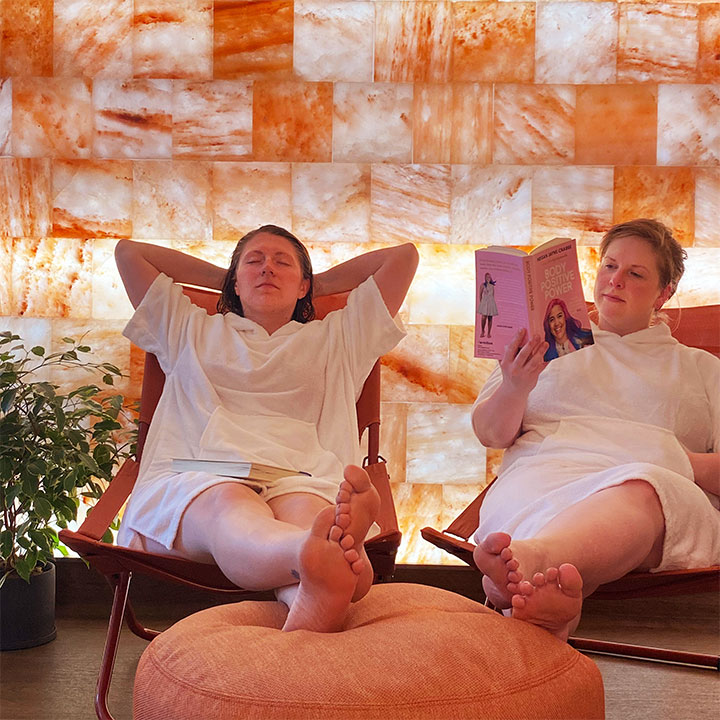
xmin=59 ymin=288 xmax=402 ymax=720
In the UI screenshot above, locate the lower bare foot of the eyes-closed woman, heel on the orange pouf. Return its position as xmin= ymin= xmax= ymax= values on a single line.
xmin=283 ymin=506 xmax=366 ymax=632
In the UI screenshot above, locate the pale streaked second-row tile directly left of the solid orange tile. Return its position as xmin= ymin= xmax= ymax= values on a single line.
xmin=172 ymin=80 xmax=252 ymax=160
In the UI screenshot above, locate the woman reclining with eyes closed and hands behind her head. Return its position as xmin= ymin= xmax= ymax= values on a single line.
xmin=115 ymin=225 xmax=417 ymax=632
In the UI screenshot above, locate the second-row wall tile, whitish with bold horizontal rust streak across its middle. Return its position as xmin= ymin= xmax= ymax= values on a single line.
xmin=93 ymin=79 xmax=172 ymax=158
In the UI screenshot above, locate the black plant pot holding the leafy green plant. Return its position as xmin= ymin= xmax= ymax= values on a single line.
xmin=0 ymin=563 xmax=57 ymax=650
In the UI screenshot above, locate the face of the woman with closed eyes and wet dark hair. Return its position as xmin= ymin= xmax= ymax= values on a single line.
xmin=235 ymin=232 xmax=310 ymax=325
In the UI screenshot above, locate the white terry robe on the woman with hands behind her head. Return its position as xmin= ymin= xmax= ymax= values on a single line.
xmin=118 ymin=273 xmax=405 ymax=548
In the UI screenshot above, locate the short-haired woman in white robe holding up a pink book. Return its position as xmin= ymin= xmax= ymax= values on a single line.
xmin=472 ymin=220 xmax=720 ymax=638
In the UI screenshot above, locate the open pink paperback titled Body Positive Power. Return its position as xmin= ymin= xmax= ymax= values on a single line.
xmin=475 ymin=238 xmax=593 ymax=361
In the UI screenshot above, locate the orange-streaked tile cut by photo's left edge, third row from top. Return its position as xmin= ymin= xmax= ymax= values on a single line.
xmin=0 ymin=158 xmax=51 ymax=237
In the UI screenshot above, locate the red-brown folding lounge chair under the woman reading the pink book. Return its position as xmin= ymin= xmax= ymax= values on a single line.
xmin=421 ymin=305 xmax=720 ymax=670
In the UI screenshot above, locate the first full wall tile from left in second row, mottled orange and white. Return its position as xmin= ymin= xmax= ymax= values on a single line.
xmin=11 ymin=77 xmax=93 ymax=158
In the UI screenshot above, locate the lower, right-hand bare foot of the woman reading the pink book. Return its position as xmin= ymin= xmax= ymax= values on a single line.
xmin=512 ymin=563 xmax=583 ymax=640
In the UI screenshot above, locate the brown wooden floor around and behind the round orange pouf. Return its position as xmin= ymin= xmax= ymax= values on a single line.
xmin=0 ymin=577 xmax=720 ymax=720
